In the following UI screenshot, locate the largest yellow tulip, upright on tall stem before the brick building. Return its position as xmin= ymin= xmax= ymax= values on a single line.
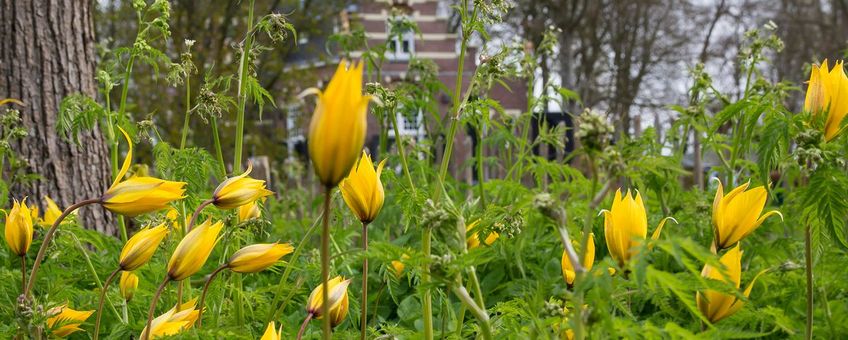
xmin=305 ymin=60 xmax=371 ymax=188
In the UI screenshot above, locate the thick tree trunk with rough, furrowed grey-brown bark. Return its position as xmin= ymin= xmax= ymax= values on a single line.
xmin=0 ymin=0 xmax=117 ymax=235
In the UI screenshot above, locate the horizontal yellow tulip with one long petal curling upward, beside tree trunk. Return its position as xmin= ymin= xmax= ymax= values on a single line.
xmin=100 ymin=128 xmax=186 ymax=217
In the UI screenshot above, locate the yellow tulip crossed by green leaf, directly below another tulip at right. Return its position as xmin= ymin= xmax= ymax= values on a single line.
xmin=695 ymin=244 xmax=766 ymax=323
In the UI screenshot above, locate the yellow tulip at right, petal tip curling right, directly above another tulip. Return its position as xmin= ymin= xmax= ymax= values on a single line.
xmin=713 ymin=181 xmax=783 ymax=250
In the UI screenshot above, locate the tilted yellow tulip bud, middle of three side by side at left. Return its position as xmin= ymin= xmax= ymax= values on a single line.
xmin=168 ymin=220 xmax=224 ymax=281
